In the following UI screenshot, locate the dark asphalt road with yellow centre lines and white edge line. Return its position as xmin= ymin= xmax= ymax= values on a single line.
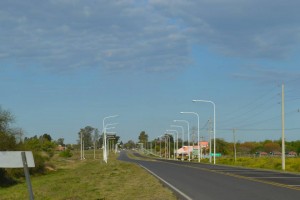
xmin=119 ymin=151 xmax=300 ymax=200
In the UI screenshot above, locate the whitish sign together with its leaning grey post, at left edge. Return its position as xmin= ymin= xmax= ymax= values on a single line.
xmin=0 ymin=151 xmax=35 ymax=200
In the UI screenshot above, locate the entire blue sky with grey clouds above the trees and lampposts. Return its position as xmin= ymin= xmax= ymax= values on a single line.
xmin=0 ymin=0 xmax=300 ymax=143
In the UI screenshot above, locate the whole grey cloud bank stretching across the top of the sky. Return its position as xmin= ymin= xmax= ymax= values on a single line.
xmin=0 ymin=0 xmax=300 ymax=71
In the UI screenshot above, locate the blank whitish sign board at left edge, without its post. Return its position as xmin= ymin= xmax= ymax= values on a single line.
xmin=0 ymin=151 xmax=35 ymax=168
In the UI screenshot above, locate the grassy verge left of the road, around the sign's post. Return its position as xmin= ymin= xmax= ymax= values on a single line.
xmin=0 ymin=152 xmax=176 ymax=200
